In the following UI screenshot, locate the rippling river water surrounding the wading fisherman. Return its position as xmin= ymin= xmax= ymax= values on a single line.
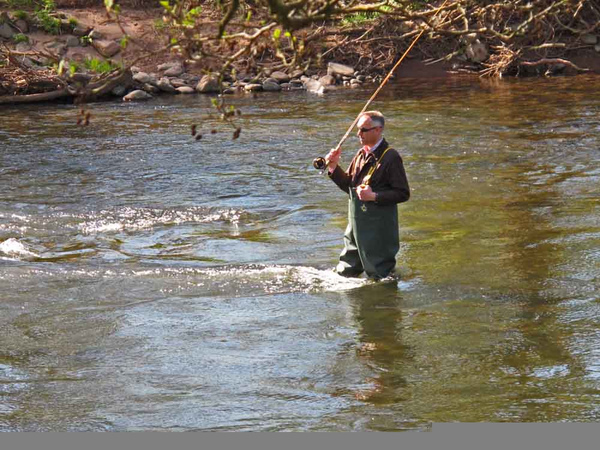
xmin=0 ymin=76 xmax=600 ymax=431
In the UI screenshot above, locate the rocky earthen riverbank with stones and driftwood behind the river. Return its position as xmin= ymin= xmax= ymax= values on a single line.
xmin=0 ymin=5 xmax=600 ymax=104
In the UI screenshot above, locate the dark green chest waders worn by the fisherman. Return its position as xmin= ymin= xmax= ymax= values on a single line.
xmin=336 ymin=148 xmax=400 ymax=278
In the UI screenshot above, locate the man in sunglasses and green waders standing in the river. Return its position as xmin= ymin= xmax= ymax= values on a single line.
xmin=325 ymin=111 xmax=410 ymax=279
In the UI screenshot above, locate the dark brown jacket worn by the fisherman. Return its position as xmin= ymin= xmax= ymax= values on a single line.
xmin=329 ymin=139 xmax=410 ymax=205
